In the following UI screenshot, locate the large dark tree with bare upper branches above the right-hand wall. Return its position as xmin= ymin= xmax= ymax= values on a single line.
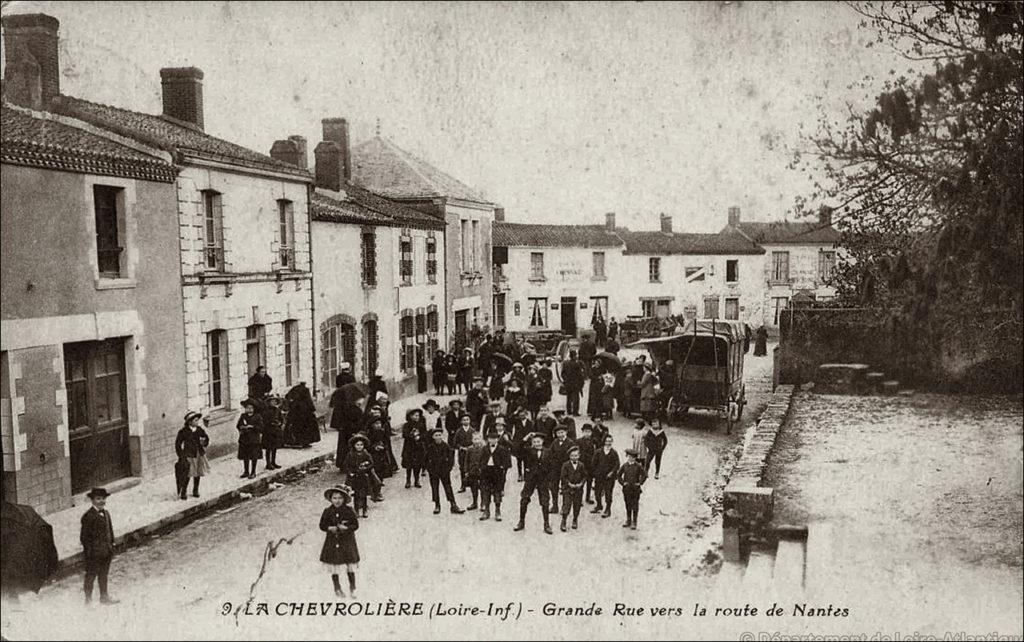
xmin=797 ymin=1 xmax=1024 ymax=387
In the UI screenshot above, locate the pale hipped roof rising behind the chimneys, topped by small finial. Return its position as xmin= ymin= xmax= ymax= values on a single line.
xmin=351 ymin=136 xmax=492 ymax=205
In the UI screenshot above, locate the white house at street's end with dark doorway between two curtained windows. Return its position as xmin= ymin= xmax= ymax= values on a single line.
xmin=493 ymin=214 xmax=630 ymax=335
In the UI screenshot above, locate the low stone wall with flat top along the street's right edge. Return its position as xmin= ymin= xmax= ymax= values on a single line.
xmin=722 ymin=385 xmax=795 ymax=561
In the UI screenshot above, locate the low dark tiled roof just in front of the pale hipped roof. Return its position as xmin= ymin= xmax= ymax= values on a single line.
xmin=310 ymin=185 xmax=444 ymax=229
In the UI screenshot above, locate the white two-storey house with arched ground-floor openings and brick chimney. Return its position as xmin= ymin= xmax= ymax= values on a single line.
xmin=280 ymin=119 xmax=446 ymax=397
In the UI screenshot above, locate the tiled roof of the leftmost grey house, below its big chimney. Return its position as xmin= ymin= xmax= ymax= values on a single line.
xmin=0 ymin=104 xmax=177 ymax=182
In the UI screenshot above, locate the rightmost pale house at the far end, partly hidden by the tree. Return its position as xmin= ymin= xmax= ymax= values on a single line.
xmin=722 ymin=207 xmax=840 ymax=333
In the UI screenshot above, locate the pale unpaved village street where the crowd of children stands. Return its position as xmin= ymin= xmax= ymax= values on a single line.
xmin=3 ymin=354 xmax=771 ymax=639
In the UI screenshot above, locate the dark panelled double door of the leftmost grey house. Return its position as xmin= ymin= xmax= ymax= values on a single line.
xmin=65 ymin=339 xmax=131 ymax=494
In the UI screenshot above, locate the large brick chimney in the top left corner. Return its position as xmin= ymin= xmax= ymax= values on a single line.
xmin=2 ymin=13 xmax=60 ymax=106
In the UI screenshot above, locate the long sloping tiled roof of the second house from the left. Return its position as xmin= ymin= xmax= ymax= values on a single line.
xmin=52 ymin=95 xmax=312 ymax=179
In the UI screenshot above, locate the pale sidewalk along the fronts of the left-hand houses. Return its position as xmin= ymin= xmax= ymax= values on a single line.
xmin=43 ymin=394 xmax=452 ymax=570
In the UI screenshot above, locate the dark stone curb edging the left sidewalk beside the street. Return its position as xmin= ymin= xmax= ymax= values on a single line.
xmin=52 ymin=453 xmax=334 ymax=580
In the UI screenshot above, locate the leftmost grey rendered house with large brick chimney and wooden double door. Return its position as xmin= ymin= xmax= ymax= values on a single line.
xmin=0 ymin=14 xmax=185 ymax=512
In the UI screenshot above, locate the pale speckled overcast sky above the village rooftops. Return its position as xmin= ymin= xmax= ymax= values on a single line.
xmin=4 ymin=0 xmax=917 ymax=231
